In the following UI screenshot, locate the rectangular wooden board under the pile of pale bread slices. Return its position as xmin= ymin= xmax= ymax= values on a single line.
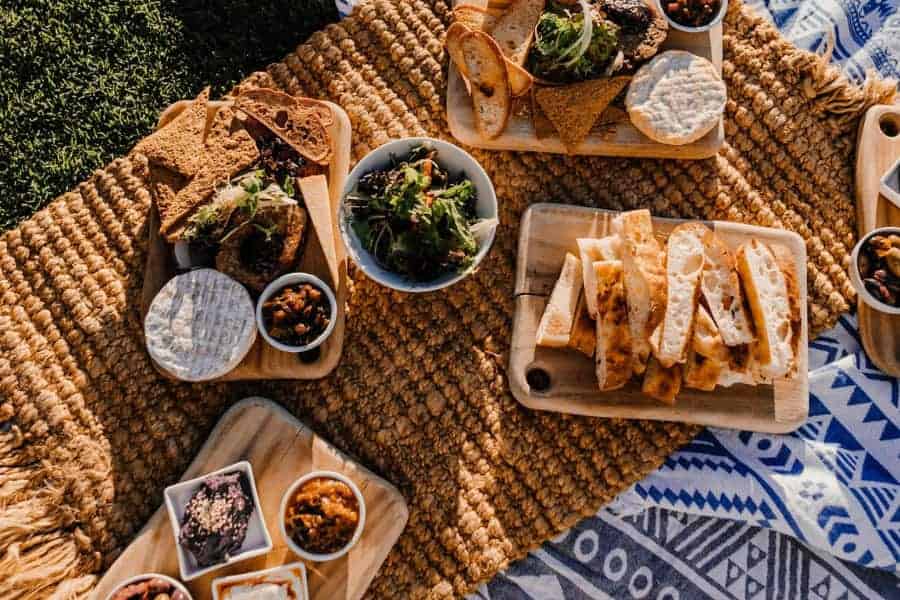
xmin=509 ymin=204 xmax=809 ymax=433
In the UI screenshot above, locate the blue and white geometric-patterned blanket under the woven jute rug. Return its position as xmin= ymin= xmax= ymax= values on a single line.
xmin=336 ymin=0 xmax=900 ymax=600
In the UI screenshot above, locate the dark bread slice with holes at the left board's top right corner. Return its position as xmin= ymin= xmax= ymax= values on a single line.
xmin=235 ymin=88 xmax=334 ymax=165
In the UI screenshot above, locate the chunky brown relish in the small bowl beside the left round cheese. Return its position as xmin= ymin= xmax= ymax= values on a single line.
xmin=262 ymin=283 xmax=331 ymax=346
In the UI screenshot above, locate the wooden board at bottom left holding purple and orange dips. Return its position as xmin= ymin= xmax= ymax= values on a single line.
xmin=94 ymin=398 xmax=409 ymax=600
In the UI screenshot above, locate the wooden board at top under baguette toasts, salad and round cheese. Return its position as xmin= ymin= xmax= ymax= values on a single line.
xmin=447 ymin=0 xmax=725 ymax=159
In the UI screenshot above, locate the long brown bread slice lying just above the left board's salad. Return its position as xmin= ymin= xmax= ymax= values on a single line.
xmin=157 ymin=106 xmax=259 ymax=243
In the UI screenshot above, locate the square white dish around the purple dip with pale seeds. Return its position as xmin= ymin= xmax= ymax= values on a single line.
xmin=163 ymin=460 xmax=272 ymax=581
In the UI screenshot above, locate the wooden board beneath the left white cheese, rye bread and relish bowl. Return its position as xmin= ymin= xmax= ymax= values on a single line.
xmin=141 ymin=101 xmax=351 ymax=381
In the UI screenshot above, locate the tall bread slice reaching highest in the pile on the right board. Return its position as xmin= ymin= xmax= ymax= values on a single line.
xmin=613 ymin=209 xmax=666 ymax=375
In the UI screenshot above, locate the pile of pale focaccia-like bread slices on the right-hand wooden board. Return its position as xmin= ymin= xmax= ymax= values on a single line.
xmin=536 ymin=210 xmax=802 ymax=404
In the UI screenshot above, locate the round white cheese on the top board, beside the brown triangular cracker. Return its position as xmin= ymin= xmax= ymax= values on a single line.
xmin=625 ymin=50 xmax=727 ymax=145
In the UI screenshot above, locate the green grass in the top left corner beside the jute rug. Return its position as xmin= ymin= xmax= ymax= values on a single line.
xmin=0 ymin=0 xmax=337 ymax=230
